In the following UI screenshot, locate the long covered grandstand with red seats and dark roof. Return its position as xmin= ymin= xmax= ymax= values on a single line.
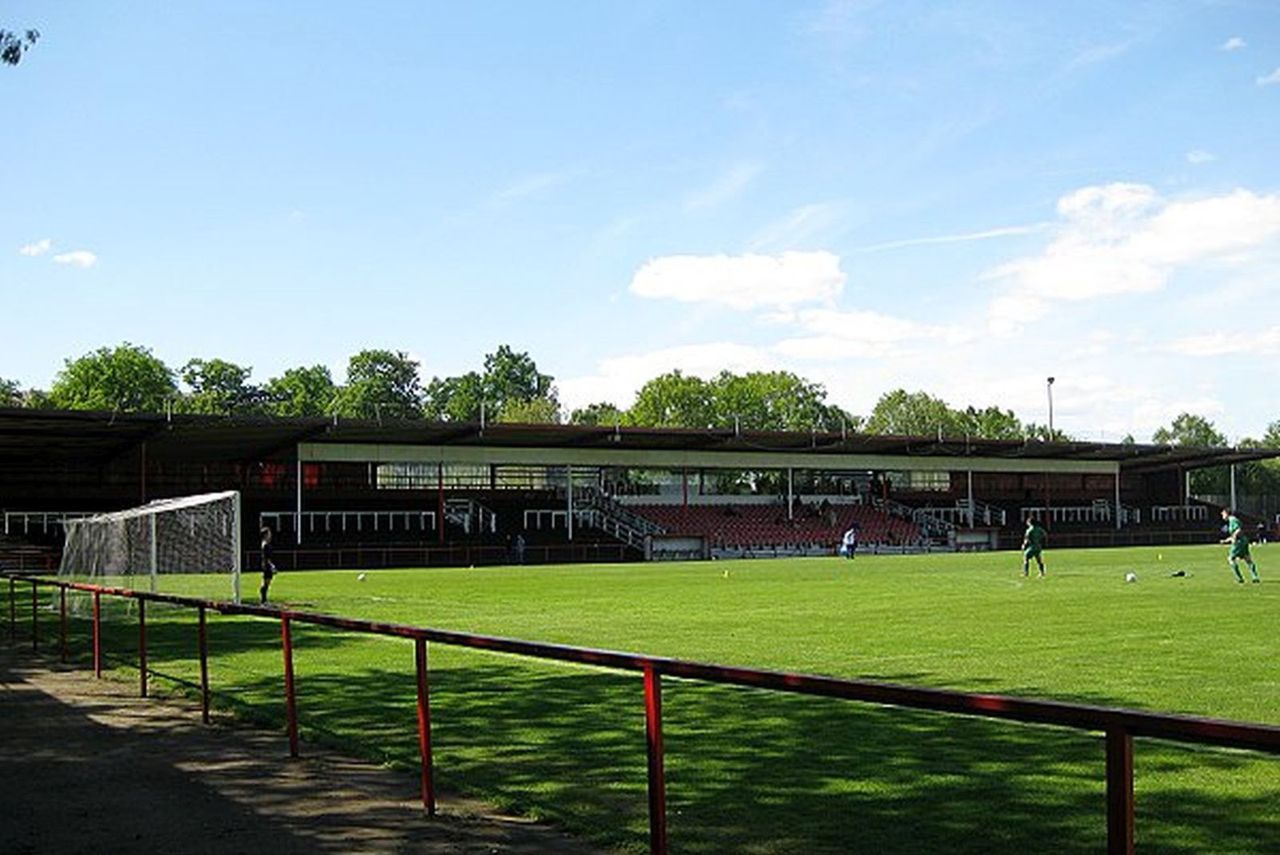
xmin=0 ymin=410 xmax=1280 ymax=568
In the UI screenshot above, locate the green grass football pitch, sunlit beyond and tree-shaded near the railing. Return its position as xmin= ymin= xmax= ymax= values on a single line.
xmin=32 ymin=547 xmax=1280 ymax=854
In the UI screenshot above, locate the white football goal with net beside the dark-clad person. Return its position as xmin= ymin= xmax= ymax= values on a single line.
xmin=58 ymin=490 xmax=241 ymax=611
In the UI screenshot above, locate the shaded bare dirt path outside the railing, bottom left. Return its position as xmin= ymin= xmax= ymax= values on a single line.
xmin=0 ymin=641 xmax=598 ymax=855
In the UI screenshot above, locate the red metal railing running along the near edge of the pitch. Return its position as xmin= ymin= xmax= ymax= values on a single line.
xmin=9 ymin=575 xmax=1280 ymax=855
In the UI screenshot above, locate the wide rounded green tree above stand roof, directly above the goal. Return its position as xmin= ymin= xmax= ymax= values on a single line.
xmin=49 ymin=342 xmax=178 ymax=412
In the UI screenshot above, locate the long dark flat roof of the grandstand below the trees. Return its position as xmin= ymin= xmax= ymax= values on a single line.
xmin=0 ymin=408 xmax=1280 ymax=474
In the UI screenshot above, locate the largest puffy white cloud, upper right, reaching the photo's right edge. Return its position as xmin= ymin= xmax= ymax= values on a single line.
xmin=986 ymin=184 xmax=1280 ymax=333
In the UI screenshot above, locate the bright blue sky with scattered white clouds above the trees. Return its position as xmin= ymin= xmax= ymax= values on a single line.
xmin=0 ymin=0 xmax=1280 ymax=442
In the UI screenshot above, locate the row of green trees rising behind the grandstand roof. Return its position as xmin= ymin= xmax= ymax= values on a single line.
xmin=0 ymin=342 xmax=1280 ymax=493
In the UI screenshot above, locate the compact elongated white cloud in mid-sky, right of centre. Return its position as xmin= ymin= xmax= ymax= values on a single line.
xmin=631 ymin=251 xmax=845 ymax=310
